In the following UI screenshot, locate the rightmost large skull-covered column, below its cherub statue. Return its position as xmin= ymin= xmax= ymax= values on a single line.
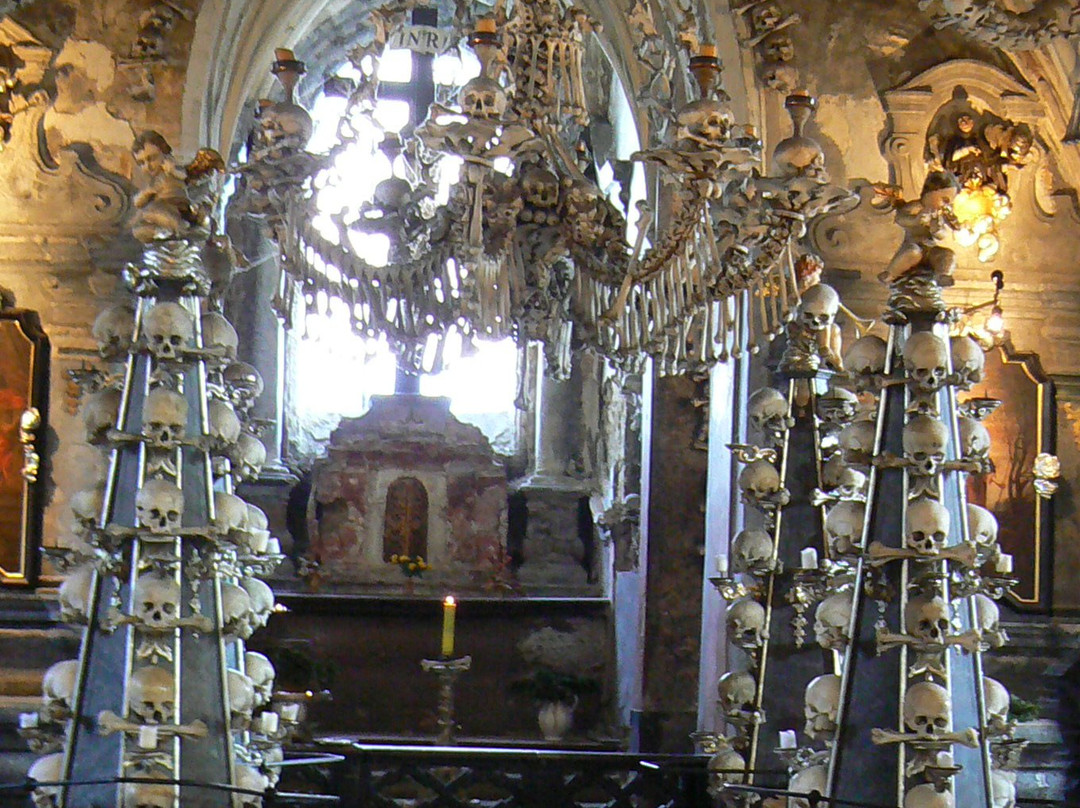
xmin=812 ymin=174 xmax=1013 ymax=808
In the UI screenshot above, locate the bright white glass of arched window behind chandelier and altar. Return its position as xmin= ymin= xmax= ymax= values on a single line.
xmin=286 ymin=37 xmax=526 ymax=459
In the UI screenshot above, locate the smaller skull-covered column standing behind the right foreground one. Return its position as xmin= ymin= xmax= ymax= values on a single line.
xmin=714 ymin=276 xmax=865 ymax=802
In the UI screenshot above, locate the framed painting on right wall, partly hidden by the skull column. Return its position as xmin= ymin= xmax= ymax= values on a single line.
xmin=966 ymin=340 xmax=1055 ymax=611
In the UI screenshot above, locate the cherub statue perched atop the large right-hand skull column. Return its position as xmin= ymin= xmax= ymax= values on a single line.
xmin=878 ymin=171 xmax=960 ymax=283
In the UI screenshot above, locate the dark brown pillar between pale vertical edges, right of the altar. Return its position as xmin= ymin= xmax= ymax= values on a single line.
xmin=639 ymin=376 xmax=708 ymax=752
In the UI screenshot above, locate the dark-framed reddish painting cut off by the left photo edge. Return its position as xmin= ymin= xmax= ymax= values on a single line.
xmin=0 ymin=308 xmax=49 ymax=585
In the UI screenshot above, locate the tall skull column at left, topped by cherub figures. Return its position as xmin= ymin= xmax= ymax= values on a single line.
xmin=27 ymin=132 xmax=281 ymax=808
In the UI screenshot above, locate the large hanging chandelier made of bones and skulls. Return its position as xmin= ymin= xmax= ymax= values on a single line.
xmin=243 ymin=0 xmax=854 ymax=376
